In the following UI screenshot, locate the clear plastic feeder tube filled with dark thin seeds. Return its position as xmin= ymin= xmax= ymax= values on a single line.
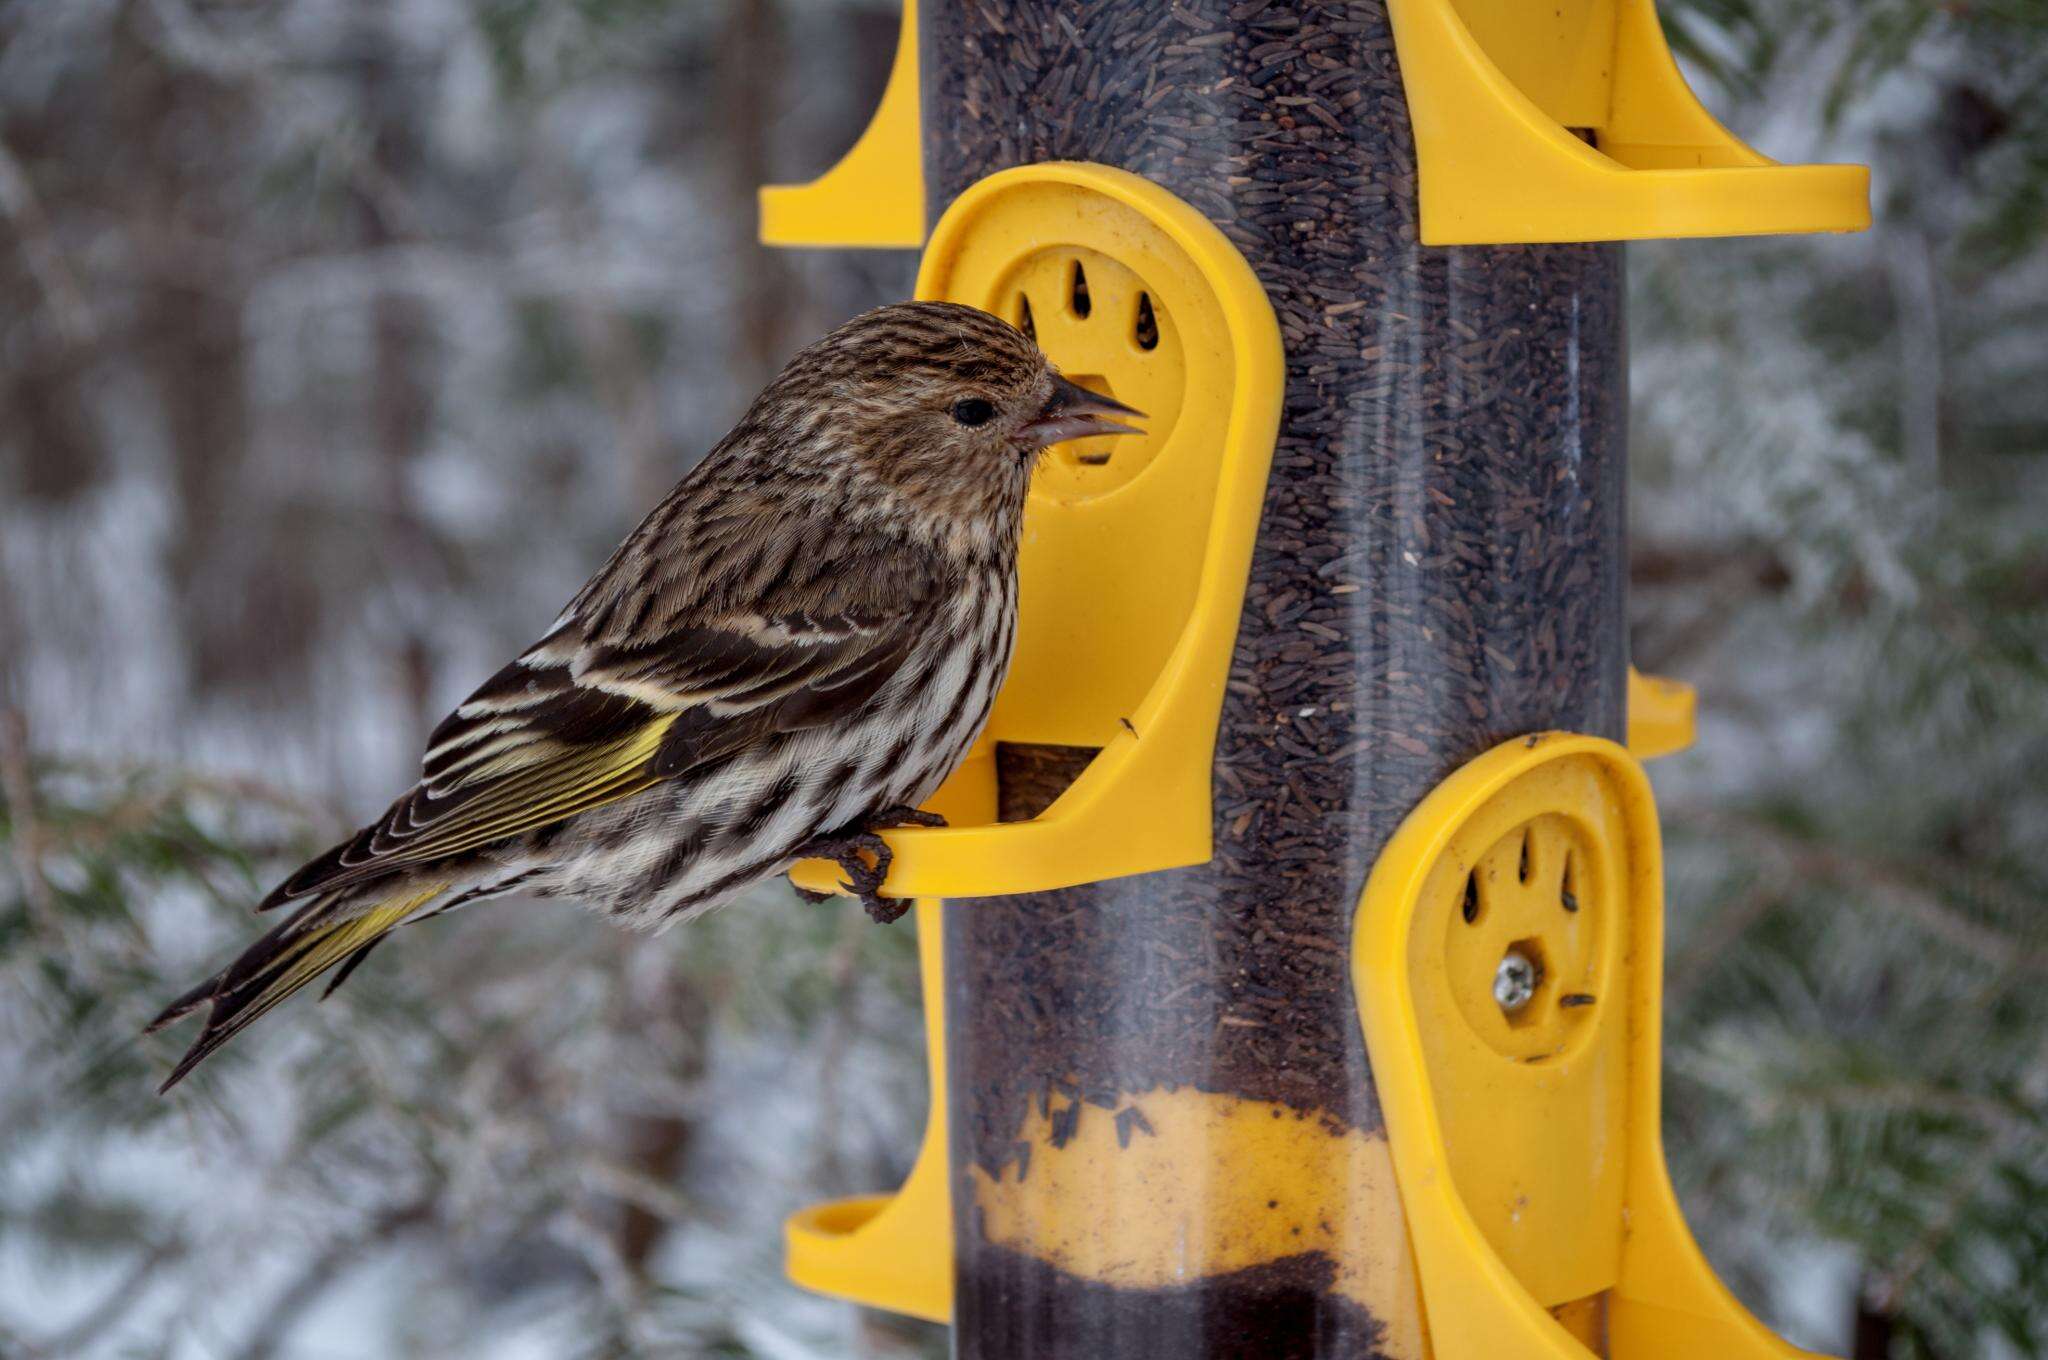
xmin=922 ymin=0 xmax=1626 ymax=1360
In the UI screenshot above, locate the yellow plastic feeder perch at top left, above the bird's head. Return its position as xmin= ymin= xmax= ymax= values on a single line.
xmin=760 ymin=0 xmax=924 ymax=248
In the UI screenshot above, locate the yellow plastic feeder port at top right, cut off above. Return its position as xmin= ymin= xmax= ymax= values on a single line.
xmin=1386 ymin=0 xmax=1870 ymax=246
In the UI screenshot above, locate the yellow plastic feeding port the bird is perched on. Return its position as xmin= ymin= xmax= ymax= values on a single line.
xmin=791 ymin=162 xmax=1284 ymax=897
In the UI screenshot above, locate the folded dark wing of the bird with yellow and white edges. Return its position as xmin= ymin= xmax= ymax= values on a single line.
xmin=262 ymin=520 xmax=934 ymax=909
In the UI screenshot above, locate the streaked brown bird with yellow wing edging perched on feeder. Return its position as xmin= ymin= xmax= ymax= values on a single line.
xmin=147 ymin=301 xmax=1143 ymax=1092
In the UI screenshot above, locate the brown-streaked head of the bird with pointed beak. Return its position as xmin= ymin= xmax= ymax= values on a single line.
xmin=764 ymin=303 xmax=1143 ymax=540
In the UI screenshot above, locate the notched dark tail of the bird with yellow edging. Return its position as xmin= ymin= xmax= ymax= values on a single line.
xmin=143 ymin=881 xmax=449 ymax=1096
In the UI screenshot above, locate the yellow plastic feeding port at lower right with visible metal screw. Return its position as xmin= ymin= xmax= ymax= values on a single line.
xmin=1352 ymin=733 xmax=1806 ymax=1360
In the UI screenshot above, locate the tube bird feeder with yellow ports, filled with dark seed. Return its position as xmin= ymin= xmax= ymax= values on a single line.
xmin=762 ymin=0 xmax=1868 ymax=1360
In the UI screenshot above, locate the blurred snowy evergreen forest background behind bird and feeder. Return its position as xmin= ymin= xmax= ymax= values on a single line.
xmin=0 ymin=0 xmax=2048 ymax=1360
